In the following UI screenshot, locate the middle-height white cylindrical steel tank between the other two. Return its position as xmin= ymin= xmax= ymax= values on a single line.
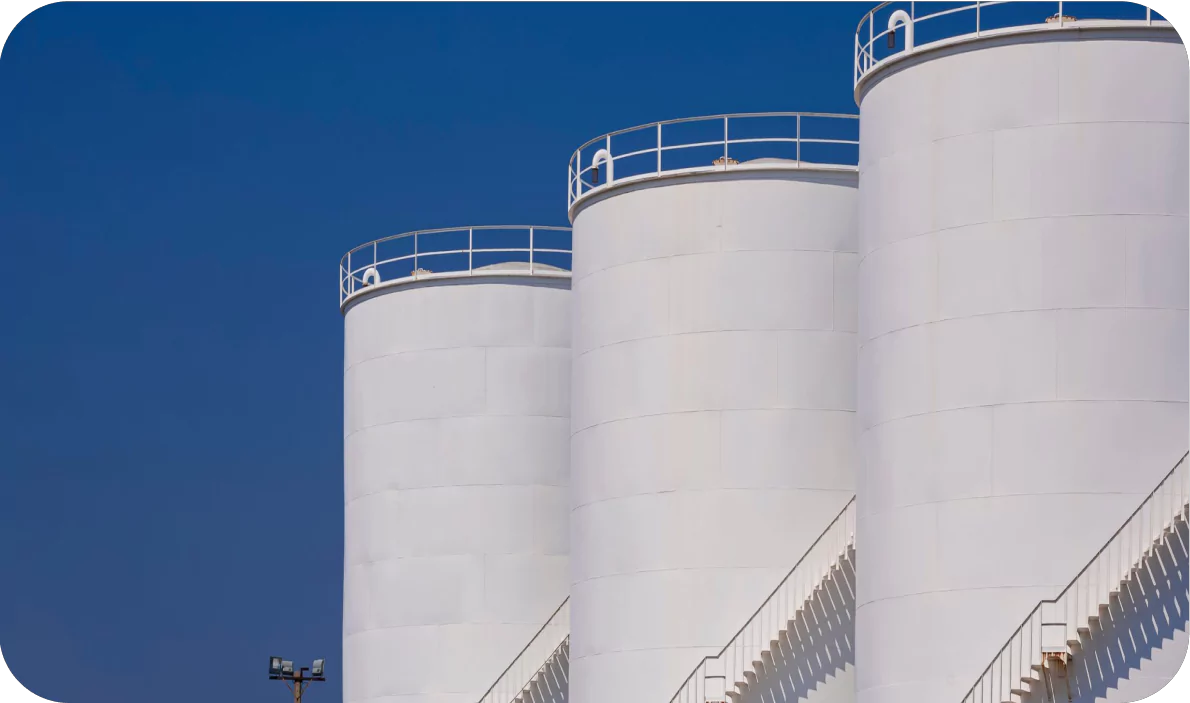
xmin=570 ymin=117 xmax=857 ymax=703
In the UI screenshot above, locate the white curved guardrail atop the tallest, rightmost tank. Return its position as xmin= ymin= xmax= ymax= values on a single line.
xmin=854 ymin=0 xmax=1167 ymax=86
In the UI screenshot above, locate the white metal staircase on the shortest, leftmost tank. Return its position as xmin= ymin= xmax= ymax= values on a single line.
xmin=480 ymin=597 xmax=570 ymax=703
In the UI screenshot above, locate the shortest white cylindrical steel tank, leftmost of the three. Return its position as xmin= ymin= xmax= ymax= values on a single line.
xmin=340 ymin=228 xmax=570 ymax=703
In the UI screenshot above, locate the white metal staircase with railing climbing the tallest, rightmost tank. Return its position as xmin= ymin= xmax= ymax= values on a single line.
xmin=963 ymin=453 xmax=1190 ymax=703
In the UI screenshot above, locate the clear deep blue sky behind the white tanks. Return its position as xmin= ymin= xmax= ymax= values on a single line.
xmin=0 ymin=2 xmax=1151 ymax=703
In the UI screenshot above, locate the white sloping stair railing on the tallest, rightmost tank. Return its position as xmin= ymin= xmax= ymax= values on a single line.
xmin=963 ymin=453 xmax=1190 ymax=703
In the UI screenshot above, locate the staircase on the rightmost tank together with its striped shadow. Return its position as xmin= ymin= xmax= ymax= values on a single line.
xmin=963 ymin=452 xmax=1190 ymax=703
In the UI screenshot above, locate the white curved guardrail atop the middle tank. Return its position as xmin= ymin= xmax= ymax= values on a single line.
xmin=566 ymin=112 xmax=859 ymax=209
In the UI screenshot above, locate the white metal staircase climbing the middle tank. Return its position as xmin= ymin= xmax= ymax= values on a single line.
xmin=670 ymin=497 xmax=856 ymax=703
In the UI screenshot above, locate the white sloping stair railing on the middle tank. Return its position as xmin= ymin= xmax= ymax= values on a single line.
xmin=670 ymin=497 xmax=856 ymax=703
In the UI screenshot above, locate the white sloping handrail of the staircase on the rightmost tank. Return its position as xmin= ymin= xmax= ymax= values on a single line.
xmin=963 ymin=451 xmax=1190 ymax=703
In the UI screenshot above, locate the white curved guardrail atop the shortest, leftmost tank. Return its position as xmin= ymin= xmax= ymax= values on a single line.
xmin=339 ymin=225 xmax=571 ymax=308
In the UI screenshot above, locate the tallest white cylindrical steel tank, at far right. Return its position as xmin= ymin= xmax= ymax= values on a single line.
xmin=856 ymin=12 xmax=1190 ymax=703
